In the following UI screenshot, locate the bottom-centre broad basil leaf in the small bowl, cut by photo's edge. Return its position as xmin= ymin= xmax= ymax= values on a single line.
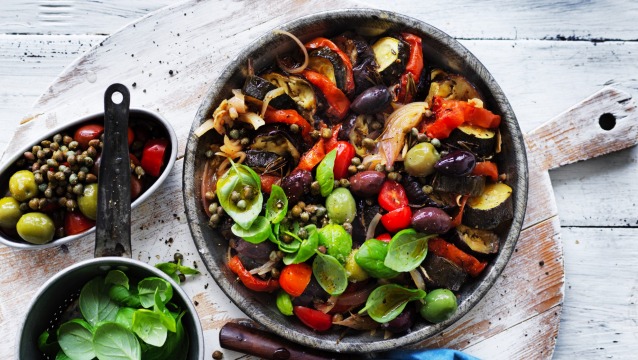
xmin=93 ymin=322 xmax=142 ymax=360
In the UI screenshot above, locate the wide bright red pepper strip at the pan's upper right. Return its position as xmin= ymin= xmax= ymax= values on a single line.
xmin=426 ymin=96 xmax=501 ymax=139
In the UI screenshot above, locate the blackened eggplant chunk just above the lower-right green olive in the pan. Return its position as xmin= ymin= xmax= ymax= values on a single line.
xmin=421 ymin=253 xmax=467 ymax=291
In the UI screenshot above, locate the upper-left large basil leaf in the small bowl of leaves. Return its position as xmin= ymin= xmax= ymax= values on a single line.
xmin=80 ymin=277 xmax=119 ymax=326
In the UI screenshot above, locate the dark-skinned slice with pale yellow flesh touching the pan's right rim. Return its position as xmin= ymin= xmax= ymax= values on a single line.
xmin=463 ymin=183 xmax=514 ymax=230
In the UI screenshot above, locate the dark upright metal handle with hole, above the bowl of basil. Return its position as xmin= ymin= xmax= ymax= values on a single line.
xmin=94 ymin=84 xmax=131 ymax=257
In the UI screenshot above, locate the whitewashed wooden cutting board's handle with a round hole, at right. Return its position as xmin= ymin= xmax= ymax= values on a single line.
xmin=525 ymin=87 xmax=638 ymax=170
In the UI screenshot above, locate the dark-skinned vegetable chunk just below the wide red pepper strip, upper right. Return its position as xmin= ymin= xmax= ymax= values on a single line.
xmin=445 ymin=124 xmax=497 ymax=158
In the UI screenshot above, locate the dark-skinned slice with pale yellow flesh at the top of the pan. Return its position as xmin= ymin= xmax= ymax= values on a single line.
xmin=372 ymin=36 xmax=410 ymax=86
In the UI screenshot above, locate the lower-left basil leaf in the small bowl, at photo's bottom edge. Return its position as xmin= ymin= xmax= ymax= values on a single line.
xmin=58 ymin=319 xmax=95 ymax=360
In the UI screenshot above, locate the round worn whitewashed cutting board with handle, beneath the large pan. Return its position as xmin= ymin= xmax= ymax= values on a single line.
xmin=0 ymin=0 xmax=638 ymax=359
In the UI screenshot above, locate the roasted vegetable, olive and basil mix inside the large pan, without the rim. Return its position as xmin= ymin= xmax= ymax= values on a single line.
xmin=195 ymin=31 xmax=513 ymax=336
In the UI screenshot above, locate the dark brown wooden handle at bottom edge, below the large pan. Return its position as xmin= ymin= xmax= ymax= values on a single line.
xmin=219 ymin=322 xmax=344 ymax=360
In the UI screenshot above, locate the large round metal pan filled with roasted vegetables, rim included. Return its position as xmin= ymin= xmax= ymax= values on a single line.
xmin=184 ymin=10 xmax=527 ymax=352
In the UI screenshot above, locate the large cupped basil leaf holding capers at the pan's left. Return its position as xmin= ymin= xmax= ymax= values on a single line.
xmin=217 ymin=161 xmax=264 ymax=229
